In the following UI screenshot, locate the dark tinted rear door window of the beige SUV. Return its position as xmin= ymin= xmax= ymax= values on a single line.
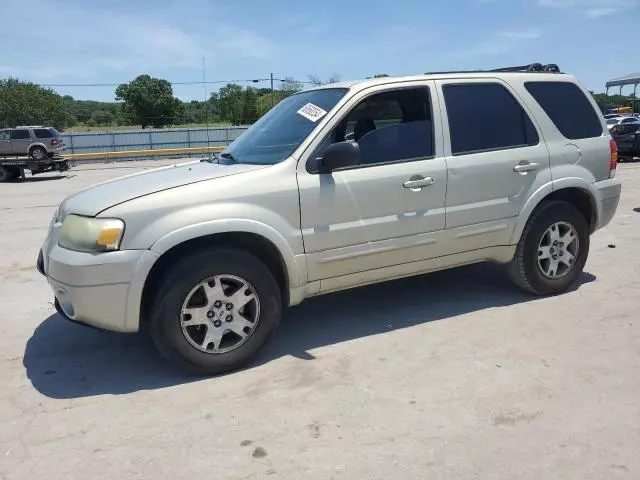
xmin=443 ymin=83 xmax=538 ymax=155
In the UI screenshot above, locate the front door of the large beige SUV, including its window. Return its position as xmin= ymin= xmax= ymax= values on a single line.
xmin=298 ymin=82 xmax=447 ymax=281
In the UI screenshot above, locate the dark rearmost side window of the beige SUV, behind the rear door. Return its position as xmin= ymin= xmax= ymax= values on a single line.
xmin=525 ymin=82 xmax=602 ymax=140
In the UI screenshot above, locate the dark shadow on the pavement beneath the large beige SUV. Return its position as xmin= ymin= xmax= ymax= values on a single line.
xmin=24 ymin=264 xmax=595 ymax=398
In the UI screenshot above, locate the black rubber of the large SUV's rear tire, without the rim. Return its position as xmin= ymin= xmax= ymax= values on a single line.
xmin=507 ymin=201 xmax=590 ymax=296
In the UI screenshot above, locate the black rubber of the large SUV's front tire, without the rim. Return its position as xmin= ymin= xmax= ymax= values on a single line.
xmin=149 ymin=247 xmax=282 ymax=375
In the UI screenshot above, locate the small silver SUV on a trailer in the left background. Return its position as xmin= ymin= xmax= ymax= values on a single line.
xmin=0 ymin=126 xmax=64 ymax=161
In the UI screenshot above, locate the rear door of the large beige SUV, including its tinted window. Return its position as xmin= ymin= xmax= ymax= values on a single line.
xmin=437 ymin=79 xmax=551 ymax=251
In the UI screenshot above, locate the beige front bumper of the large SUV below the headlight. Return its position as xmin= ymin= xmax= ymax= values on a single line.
xmin=37 ymin=227 xmax=158 ymax=332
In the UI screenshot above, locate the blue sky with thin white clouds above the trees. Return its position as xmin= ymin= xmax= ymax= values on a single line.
xmin=0 ymin=0 xmax=640 ymax=100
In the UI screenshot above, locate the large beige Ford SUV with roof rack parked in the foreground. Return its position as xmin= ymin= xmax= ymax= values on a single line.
xmin=38 ymin=64 xmax=620 ymax=374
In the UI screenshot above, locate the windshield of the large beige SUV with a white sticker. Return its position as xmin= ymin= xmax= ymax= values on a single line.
xmin=223 ymin=88 xmax=347 ymax=165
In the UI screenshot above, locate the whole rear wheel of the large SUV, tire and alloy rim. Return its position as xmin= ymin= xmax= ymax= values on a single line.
xmin=507 ymin=201 xmax=589 ymax=296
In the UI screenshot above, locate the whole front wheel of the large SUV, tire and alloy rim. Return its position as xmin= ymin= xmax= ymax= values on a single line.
xmin=150 ymin=248 xmax=282 ymax=375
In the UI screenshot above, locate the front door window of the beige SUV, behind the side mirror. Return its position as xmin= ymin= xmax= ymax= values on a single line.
xmin=316 ymin=87 xmax=434 ymax=165
